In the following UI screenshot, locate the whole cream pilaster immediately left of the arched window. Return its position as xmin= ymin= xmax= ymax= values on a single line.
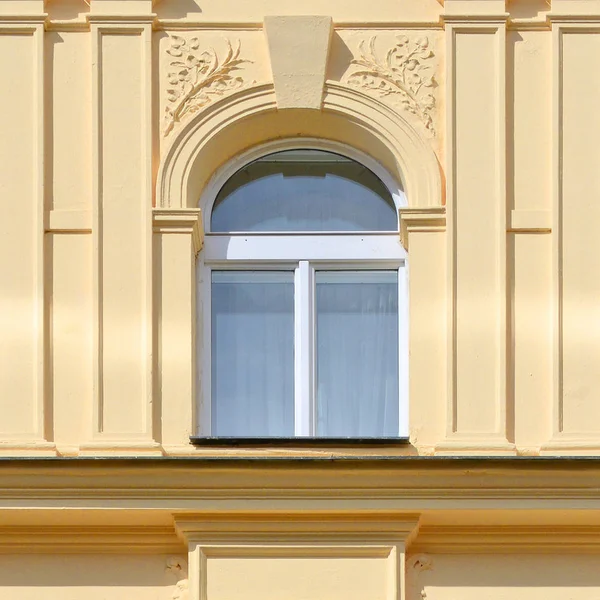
xmin=81 ymin=0 xmax=160 ymax=454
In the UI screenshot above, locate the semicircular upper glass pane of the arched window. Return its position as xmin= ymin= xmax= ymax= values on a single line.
xmin=211 ymin=150 xmax=398 ymax=232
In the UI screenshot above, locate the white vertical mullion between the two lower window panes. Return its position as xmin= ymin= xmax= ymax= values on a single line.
xmin=294 ymin=260 xmax=315 ymax=437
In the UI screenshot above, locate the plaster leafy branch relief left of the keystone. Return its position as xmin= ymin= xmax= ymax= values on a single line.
xmin=164 ymin=35 xmax=252 ymax=136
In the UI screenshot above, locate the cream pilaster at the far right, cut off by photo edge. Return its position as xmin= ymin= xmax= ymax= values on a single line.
xmin=541 ymin=0 xmax=600 ymax=455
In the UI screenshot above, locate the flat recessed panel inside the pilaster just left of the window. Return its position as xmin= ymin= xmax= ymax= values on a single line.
xmin=98 ymin=30 xmax=150 ymax=435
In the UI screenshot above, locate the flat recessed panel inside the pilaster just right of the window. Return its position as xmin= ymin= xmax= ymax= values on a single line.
xmin=453 ymin=31 xmax=504 ymax=434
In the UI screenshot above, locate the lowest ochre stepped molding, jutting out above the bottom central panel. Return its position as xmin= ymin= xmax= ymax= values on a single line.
xmin=0 ymin=512 xmax=600 ymax=552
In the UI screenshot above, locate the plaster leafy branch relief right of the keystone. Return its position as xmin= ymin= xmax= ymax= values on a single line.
xmin=345 ymin=35 xmax=436 ymax=134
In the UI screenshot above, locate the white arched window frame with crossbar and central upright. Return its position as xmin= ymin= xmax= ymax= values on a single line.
xmin=195 ymin=138 xmax=409 ymax=438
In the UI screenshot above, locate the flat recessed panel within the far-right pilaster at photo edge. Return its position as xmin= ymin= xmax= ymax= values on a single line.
xmin=558 ymin=31 xmax=600 ymax=436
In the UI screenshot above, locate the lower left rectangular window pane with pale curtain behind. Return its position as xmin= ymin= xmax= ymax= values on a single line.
xmin=211 ymin=271 xmax=294 ymax=437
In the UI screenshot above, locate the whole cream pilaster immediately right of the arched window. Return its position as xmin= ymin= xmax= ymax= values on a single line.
xmin=436 ymin=0 xmax=515 ymax=454
